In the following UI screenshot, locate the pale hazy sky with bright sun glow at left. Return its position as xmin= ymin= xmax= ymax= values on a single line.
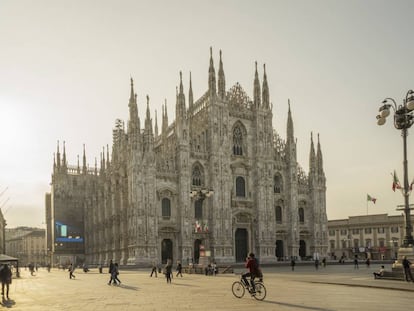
xmin=0 ymin=0 xmax=414 ymax=228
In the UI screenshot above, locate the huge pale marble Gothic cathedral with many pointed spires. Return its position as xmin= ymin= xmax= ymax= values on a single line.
xmin=46 ymin=49 xmax=328 ymax=265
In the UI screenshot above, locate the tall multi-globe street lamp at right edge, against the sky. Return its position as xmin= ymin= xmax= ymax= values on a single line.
xmin=377 ymin=90 xmax=414 ymax=247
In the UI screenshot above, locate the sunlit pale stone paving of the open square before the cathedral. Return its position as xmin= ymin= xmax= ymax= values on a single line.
xmin=3 ymin=265 xmax=414 ymax=311
